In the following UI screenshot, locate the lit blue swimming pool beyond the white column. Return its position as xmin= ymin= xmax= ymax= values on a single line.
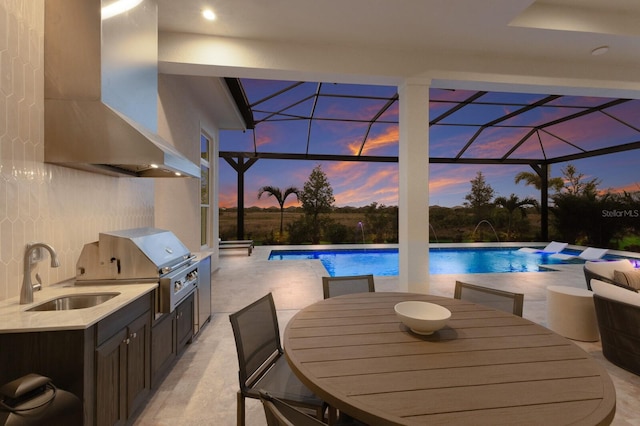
xmin=269 ymin=247 xmax=576 ymax=277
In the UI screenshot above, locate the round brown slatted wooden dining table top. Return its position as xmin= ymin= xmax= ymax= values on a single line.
xmin=284 ymin=292 xmax=616 ymax=426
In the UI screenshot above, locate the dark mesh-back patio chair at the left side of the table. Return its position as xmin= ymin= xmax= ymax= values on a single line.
xmin=229 ymin=293 xmax=327 ymax=426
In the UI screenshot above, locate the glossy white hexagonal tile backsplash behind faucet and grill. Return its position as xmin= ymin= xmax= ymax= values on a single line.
xmin=0 ymin=0 xmax=154 ymax=300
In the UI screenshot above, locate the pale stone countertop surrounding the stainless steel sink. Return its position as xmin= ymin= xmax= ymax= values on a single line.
xmin=0 ymin=280 xmax=158 ymax=334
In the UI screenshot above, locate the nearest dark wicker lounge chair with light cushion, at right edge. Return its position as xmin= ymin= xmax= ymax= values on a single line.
xmin=591 ymin=280 xmax=640 ymax=375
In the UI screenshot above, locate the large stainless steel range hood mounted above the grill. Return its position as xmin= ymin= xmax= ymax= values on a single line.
xmin=44 ymin=0 xmax=200 ymax=178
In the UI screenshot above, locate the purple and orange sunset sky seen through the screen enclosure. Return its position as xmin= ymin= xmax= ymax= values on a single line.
xmin=219 ymin=80 xmax=640 ymax=207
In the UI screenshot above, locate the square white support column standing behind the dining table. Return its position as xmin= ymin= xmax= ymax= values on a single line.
xmin=398 ymin=81 xmax=429 ymax=293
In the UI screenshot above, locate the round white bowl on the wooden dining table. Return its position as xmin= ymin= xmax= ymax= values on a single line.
xmin=393 ymin=300 xmax=451 ymax=335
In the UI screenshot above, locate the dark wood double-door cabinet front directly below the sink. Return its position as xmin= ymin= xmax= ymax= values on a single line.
xmin=95 ymin=296 xmax=151 ymax=426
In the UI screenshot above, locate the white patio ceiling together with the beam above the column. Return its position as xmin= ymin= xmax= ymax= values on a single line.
xmin=157 ymin=0 xmax=640 ymax=128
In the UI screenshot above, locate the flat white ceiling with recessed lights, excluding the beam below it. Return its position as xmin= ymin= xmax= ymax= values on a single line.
xmin=158 ymin=0 xmax=640 ymax=65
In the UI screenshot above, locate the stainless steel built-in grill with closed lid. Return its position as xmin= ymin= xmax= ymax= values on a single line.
xmin=76 ymin=228 xmax=198 ymax=312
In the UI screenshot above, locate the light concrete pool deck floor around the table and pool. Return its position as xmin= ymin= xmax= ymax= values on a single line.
xmin=134 ymin=245 xmax=640 ymax=426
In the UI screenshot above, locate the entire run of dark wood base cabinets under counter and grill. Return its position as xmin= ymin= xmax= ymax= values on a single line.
xmin=0 ymin=293 xmax=195 ymax=426
